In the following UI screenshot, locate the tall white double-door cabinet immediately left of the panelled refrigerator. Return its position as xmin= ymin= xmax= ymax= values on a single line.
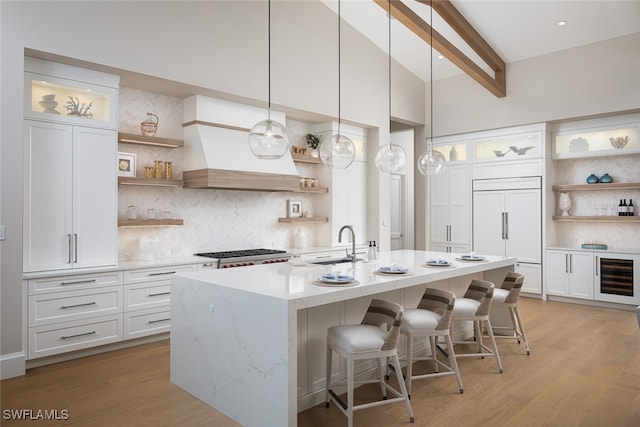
xmin=430 ymin=164 xmax=471 ymax=253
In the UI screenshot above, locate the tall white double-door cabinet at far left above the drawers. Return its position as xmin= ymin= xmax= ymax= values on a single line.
xmin=23 ymin=120 xmax=117 ymax=272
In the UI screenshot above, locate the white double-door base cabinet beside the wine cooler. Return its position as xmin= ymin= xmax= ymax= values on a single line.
xmin=545 ymin=250 xmax=595 ymax=299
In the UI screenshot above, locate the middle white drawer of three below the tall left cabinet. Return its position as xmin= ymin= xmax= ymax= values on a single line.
xmin=29 ymin=286 xmax=123 ymax=327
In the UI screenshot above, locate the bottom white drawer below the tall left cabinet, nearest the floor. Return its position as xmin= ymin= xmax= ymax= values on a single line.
xmin=28 ymin=314 xmax=122 ymax=359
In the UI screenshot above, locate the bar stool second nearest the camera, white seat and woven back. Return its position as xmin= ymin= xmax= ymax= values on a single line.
xmin=400 ymin=288 xmax=463 ymax=398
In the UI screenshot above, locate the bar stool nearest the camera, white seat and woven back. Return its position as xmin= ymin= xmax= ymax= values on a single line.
xmin=325 ymin=299 xmax=414 ymax=427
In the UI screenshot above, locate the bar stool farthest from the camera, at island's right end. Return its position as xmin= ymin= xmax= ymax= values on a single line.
xmin=491 ymin=272 xmax=531 ymax=356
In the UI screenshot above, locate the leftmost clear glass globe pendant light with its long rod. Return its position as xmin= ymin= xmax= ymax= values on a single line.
xmin=249 ymin=0 xmax=289 ymax=159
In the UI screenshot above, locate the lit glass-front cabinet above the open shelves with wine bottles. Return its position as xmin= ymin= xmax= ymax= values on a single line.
xmin=551 ymin=124 xmax=640 ymax=159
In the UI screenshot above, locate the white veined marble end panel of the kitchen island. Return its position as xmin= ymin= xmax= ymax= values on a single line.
xmin=170 ymin=275 xmax=297 ymax=426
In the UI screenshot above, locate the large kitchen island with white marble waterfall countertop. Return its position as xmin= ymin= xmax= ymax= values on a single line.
xmin=171 ymin=250 xmax=516 ymax=426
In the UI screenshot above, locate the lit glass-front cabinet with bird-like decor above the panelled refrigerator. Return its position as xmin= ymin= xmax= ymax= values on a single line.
xmin=473 ymin=131 xmax=543 ymax=162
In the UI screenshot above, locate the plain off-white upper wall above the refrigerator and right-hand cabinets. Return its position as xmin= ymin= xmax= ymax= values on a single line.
xmin=425 ymin=33 xmax=640 ymax=136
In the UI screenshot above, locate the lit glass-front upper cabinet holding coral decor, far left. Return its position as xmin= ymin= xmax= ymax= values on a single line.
xmin=24 ymin=57 xmax=119 ymax=129
